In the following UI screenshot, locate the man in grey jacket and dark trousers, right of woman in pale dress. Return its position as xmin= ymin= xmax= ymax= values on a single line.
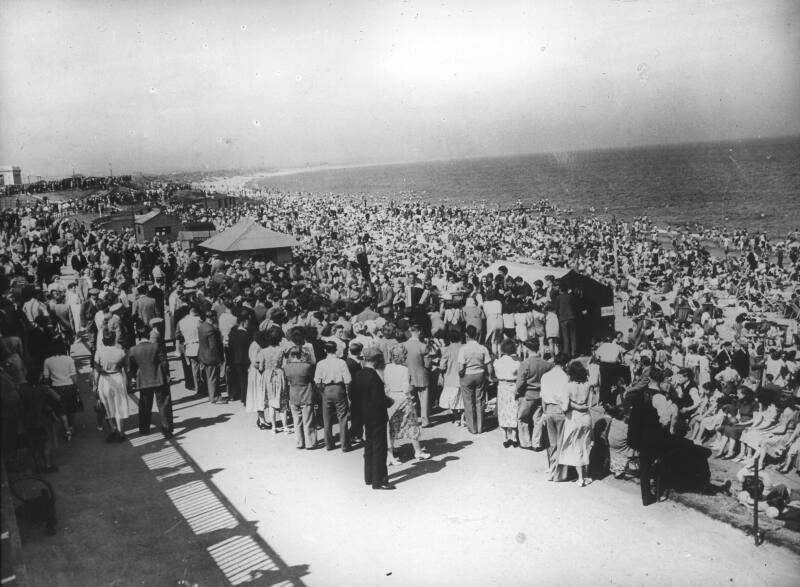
xmin=128 ymin=327 xmax=172 ymax=438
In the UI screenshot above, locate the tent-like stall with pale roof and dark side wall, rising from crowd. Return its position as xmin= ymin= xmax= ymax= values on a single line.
xmin=481 ymin=260 xmax=615 ymax=353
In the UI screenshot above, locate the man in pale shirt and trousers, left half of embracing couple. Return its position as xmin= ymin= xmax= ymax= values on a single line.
xmin=541 ymin=353 xmax=569 ymax=481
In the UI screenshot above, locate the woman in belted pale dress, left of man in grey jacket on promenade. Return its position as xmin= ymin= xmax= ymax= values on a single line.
xmin=93 ymin=330 xmax=130 ymax=442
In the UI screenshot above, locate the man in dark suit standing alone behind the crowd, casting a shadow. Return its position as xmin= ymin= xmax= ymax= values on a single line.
xmin=352 ymin=347 xmax=395 ymax=489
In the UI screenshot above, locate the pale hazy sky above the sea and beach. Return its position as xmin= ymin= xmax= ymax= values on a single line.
xmin=0 ymin=0 xmax=800 ymax=177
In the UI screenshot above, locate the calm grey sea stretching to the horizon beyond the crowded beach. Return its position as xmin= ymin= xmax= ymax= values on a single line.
xmin=259 ymin=137 xmax=800 ymax=236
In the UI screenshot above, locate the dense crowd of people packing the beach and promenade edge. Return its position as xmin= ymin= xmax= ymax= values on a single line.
xmin=0 ymin=184 xmax=800 ymax=511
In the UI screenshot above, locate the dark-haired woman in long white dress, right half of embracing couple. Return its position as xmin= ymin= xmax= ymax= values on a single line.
xmin=558 ymin=361 xmax=592 ymax=487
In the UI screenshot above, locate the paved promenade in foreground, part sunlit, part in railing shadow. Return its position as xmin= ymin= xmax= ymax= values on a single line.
xmin=15 ymin=342 xmax=800 ymax=586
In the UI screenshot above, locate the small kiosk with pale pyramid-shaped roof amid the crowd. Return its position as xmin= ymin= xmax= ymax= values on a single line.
xmin=198 ymin=219 xmax=300 ymax=264
